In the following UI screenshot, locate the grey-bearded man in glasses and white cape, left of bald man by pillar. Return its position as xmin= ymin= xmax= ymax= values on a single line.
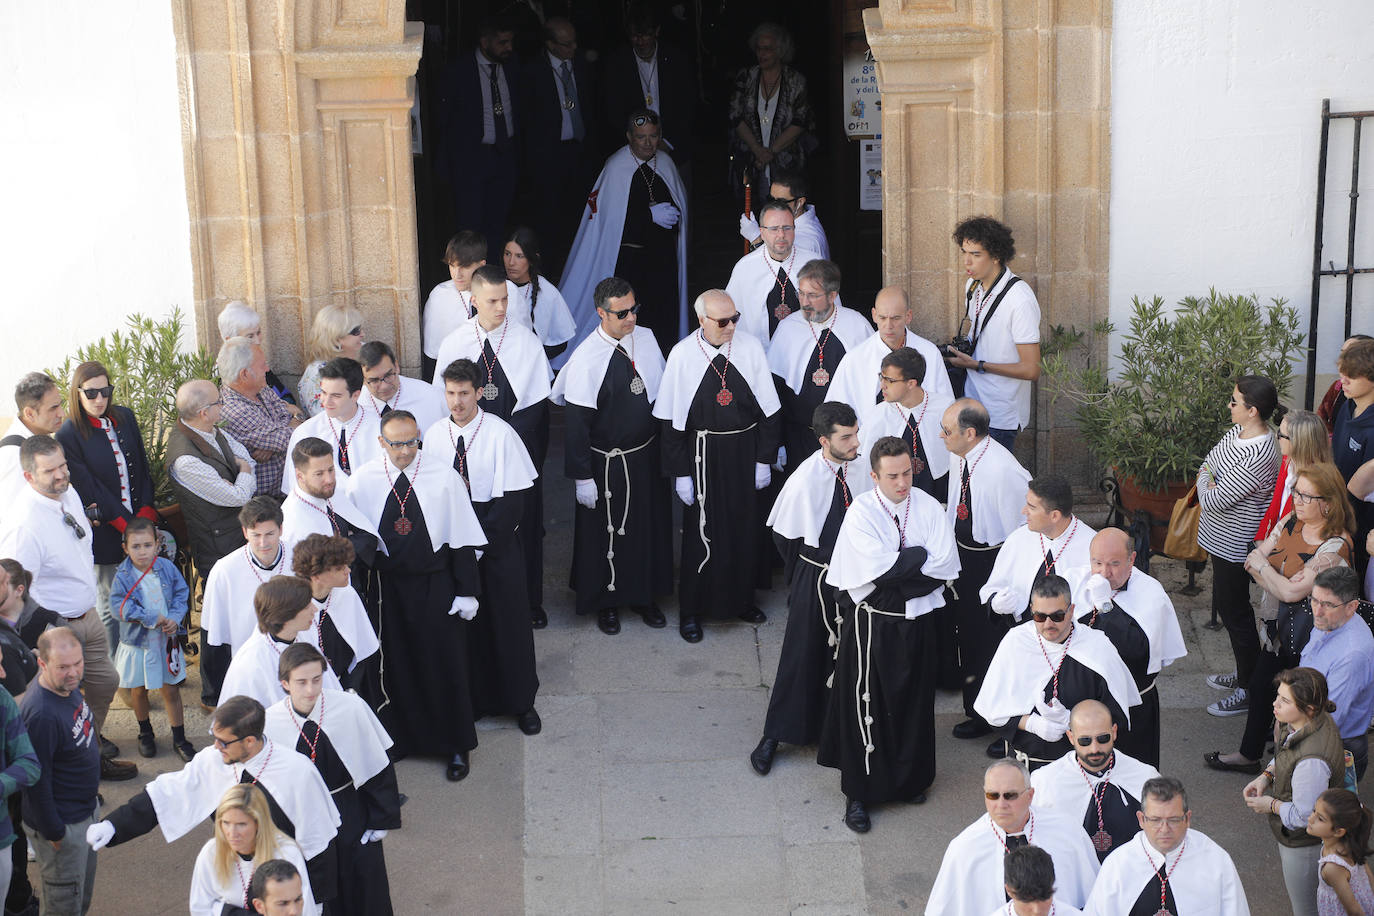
xmin=769 ymin=258 xmax=872 ymax=474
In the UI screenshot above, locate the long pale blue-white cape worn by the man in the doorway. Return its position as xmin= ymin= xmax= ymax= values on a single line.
xmin=555 ymin=146 xmax=688 ymax=363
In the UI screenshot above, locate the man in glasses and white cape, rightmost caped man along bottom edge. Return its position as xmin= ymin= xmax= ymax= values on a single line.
xmin=1083 ymin=776 xmax=1250 ymax=916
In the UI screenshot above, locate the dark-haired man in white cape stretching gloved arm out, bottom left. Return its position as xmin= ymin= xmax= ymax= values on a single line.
xmin=85 ymin=696 xmax=341 ymax=902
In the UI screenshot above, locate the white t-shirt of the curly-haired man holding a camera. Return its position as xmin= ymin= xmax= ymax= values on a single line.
xmin=965 ymin=269 xmax=1040 ymax=430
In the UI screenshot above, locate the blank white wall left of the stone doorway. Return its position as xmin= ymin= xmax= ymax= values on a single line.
xmin=0 ymin=0 xmax=194 ymax=425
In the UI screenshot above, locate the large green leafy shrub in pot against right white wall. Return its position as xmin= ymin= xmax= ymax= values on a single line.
xmin=1041 ymin=288 xmax=1304 ymax=549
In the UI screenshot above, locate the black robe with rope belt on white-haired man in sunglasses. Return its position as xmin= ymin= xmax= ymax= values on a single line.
xmin=661 ymin=354 xmax=778 ymax=619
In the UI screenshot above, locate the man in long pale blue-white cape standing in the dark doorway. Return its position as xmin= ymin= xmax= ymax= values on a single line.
xmin=558 ymin=108 xmax=688 ymax=362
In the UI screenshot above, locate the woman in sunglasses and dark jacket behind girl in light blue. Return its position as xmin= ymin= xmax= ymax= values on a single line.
xmin=56 ymin=360 xmax=158 ymax=656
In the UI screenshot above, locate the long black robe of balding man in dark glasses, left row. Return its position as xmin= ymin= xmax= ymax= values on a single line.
xmin=376 ymin=474 xmax=478 ymax=759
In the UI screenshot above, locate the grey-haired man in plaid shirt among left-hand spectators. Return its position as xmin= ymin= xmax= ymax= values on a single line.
xmin=214 ymin=336 xmax=301 ymax=496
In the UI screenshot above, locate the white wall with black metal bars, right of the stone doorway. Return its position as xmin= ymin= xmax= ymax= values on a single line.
xmin=1109 ymin=0 xmax=1374 ymax=397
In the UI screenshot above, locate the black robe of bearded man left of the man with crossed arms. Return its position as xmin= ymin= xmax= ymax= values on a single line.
xmin=764 ymin=475 xmax=848 ymax=744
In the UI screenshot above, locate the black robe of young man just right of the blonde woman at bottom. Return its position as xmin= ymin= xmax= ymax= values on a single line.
xmin=295 ymin=719 xmax=398 ymax=916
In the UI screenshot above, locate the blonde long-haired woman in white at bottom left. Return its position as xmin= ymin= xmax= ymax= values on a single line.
xmin=191 ymin=783 xmax=322 ymax=916
